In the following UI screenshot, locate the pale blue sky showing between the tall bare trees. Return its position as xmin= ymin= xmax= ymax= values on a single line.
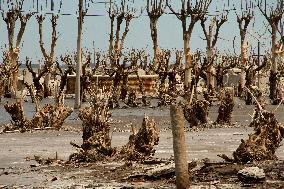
xmin=0 ymin=0 xmax=276 ymax=60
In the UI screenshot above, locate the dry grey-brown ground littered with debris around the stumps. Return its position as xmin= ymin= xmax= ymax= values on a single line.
xmin=0 ymin=100 xmax=284 ymax=188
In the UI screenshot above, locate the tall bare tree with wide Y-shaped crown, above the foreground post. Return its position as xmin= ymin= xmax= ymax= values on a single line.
xmin=167 ymin=0 xmax=212 ymax=88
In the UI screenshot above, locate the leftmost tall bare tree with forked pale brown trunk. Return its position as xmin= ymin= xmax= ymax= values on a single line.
xmin=2 ymin=0 xmax=33 ymax=97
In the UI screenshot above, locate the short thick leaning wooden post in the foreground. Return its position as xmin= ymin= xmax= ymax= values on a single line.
xmin=171 ymin=105 xmax=189 ymax=189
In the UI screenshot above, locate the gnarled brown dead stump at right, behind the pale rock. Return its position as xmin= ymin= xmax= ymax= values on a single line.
xmin=233 ymin=110 xmax=284 ymax=163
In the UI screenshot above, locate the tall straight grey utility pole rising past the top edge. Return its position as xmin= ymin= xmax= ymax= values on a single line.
xmin=74 ymin=0 xmax=83 ymax=109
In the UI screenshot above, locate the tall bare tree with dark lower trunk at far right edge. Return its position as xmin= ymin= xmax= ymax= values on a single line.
xmin=258 ymin=0 xmax=284 ymax=104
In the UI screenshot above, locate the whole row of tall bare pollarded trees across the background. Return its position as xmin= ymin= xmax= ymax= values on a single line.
xmin=2 ymin=0 xmax=284 ymax=103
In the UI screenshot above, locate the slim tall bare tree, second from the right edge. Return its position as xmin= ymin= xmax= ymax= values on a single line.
xmin=236 ymin=1 xmax=254 ymax=95
